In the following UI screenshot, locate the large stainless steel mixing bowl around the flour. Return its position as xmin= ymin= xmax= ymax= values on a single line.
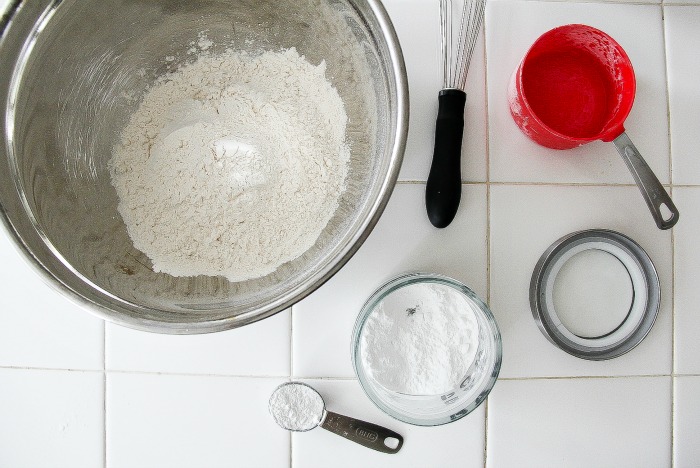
xmin=0 ymin=0 xmax=408 ymax=334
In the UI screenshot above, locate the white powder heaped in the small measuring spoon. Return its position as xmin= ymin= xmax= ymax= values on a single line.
xmin=269 ymin=383 xmax=324 ymax=431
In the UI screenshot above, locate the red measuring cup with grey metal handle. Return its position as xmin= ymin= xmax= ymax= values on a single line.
xmin=508 ymin=24 xmax=679 ymax=229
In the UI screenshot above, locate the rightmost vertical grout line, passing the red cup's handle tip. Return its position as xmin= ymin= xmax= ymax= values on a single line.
xmin=661 ymin=4 xmax=676 ymax=468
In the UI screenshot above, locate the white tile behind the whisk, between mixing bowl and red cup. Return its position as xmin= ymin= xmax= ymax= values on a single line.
xmin=384 ymin=0 xmax=486 ymax=182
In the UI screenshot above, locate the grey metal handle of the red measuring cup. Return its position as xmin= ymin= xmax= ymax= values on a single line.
xmin=613 ymin=132 xmax=680 ymax=229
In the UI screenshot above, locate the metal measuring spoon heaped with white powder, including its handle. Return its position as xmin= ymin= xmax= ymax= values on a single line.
xmin=268 ymin=382 xmax=403 ymax=453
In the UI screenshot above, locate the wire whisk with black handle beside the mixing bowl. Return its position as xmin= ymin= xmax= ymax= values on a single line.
xmin=425 ymin=0 xmax=486 ymax=228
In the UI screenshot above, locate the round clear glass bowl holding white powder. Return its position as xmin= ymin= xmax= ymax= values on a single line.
xmin=351 ymin=273 xmax=502 ymax=426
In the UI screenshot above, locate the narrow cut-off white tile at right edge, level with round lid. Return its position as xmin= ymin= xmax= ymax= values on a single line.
xmin=673 ymin=187 xmax=700 ymax=374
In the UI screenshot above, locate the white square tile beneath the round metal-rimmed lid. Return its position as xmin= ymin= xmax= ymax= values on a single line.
xmin=490 ymin=186 xmax=672 ymax=377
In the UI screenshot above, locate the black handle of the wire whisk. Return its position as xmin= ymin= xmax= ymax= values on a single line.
xmin=425 ymin=89 xmax=467 ymax=228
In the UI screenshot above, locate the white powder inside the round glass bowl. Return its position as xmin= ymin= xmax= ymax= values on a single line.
xmin=360 ymin=284 xmax=479 ymax=395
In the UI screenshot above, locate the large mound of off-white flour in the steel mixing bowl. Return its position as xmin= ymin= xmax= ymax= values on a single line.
xmin=110 ymin=47 xmax=350 ymax=281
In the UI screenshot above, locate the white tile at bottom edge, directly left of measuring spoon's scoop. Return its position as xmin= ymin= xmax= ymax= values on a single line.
xmin=106 ymin=373 xmax=290 ymax=468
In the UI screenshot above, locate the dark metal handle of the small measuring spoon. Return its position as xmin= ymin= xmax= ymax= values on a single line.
xmin=321 ymin=411 xmax=403 ymax=453
